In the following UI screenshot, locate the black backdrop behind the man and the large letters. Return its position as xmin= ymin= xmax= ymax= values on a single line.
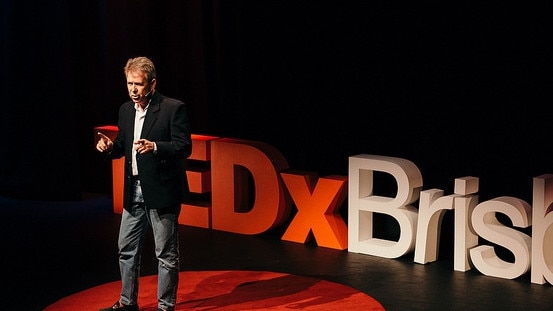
xmin=0 ymin=0 xmax=553 ymax=208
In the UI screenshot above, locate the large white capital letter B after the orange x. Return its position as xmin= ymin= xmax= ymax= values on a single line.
xmin=348 ymin=154 xmax=422 ymax=258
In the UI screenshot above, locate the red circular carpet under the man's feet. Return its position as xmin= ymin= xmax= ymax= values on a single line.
xmin=44 ymin=271 xmax=384 ymax=311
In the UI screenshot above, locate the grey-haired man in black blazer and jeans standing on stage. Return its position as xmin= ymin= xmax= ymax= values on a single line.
xmin=96 ymin=57 xmax=192 ymax=311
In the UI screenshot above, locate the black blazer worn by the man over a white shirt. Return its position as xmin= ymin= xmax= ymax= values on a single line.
xmin=106 ymin=92 xmax=192 ymax=210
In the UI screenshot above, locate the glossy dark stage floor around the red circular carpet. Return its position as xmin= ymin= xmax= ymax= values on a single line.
xmin=0 ymin=196 xmax=553 ymax=311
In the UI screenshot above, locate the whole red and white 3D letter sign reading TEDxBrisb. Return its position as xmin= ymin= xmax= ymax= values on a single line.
xmin=95 ymin=126 xmax=553 ymax=284
